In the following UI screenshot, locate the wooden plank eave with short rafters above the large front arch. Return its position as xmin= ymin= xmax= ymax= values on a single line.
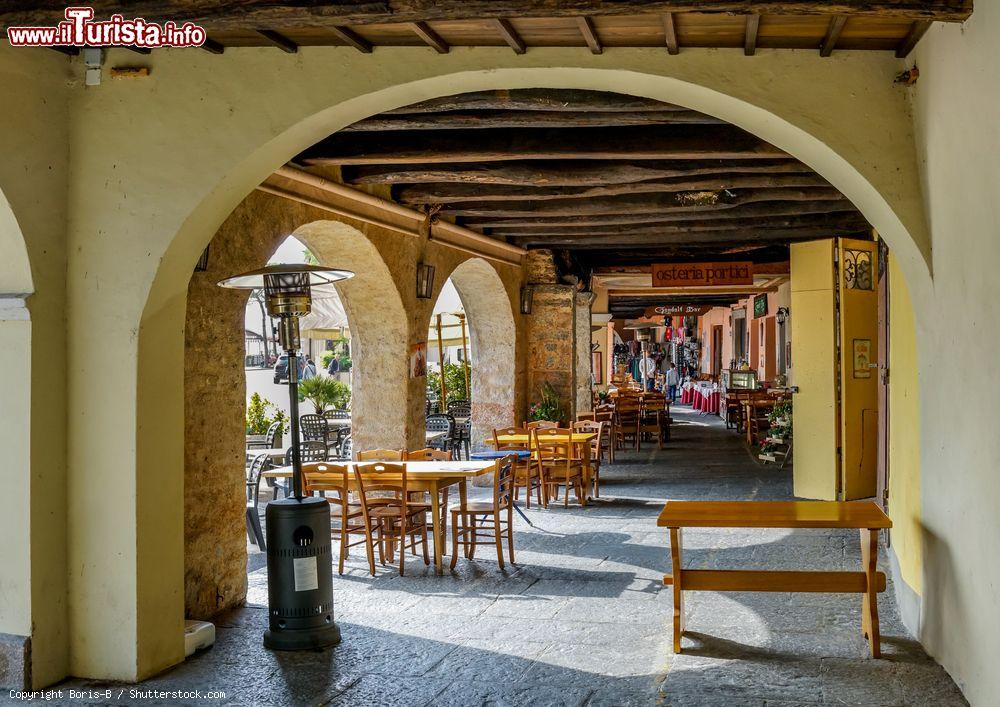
xmin=0 ymin=0 xmax=973 ymax=56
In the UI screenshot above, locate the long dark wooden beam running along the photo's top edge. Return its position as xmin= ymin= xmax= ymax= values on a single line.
xmin=0 ymin=0 xmax=973 ymax=30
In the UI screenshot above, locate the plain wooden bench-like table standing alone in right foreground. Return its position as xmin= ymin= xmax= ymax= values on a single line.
xmin=656 ymin=501 xmax=892 ymax=658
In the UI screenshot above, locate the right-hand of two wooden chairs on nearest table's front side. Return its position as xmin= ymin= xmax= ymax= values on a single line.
xmin=354 ymin=462 xmax=431 ymax=576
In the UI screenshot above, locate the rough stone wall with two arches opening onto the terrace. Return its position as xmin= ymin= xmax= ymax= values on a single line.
xmin=184 ymin=192 xmax=536 ymax=619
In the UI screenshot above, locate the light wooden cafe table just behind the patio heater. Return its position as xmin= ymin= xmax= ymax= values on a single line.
xmin=262 ymin=461 xmax=496 ymax=573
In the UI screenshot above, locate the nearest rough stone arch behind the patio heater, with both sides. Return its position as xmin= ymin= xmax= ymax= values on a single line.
xmin=184 ymin=192 xmax=407 ymax=618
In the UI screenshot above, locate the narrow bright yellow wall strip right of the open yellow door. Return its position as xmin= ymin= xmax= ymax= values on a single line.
xmin=889 ymin=256 xmax=923 ymax=594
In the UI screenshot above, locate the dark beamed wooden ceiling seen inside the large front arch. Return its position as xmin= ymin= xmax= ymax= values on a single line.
xmin=294 ymin=89 xmax=871 ymax=272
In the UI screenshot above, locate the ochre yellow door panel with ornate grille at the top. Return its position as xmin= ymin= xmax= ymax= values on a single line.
xmin=838 ymin=238 xmax=879 ymax=501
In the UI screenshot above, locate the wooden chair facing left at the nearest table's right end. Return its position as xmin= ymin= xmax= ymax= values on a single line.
xmin=451 ymin=455 xmax=517 ymax=569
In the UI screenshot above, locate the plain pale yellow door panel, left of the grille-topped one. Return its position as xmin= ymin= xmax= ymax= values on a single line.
xmin=789 ymin=240 xmax=839 ymax=501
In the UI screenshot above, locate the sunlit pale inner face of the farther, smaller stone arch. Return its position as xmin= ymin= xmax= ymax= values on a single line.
xmin=450 ymin=258 xmax=517 ymax=445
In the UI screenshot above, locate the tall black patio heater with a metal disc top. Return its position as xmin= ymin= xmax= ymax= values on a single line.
xmin=219 ymin=265 xmax=354 ymax=650
